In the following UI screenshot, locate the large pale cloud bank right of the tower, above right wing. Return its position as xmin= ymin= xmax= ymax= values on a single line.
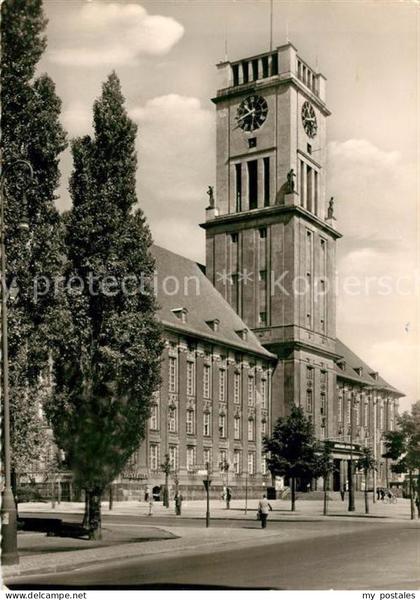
xmin=328 ymin=140 xmax=420 ymax=408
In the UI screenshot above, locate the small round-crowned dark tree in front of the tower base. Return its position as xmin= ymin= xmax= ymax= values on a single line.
xmin=264 ymin=406 xmax=316 ymax=511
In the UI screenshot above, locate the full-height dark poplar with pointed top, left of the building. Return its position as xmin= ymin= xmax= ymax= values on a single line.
xmin=47 ymin=73 xmax=163 ymax=537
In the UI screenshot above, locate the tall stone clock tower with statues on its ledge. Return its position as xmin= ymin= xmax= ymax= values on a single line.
xmin=202 ymin=43 xmax=340 ymax=438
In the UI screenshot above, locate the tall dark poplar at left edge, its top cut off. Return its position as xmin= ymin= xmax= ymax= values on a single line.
xmin=1 ymin=0 xmax=66 ymax=473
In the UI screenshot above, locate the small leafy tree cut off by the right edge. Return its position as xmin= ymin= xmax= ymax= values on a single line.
xmin=383 ymin=401 xmax=420 ymax=519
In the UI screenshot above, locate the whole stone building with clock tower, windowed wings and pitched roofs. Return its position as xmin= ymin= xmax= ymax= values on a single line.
xmin=120 ymin=43 xmax=403 ymax=497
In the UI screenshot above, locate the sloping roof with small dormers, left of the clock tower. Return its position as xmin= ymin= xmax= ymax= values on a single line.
xmin=151 ymin=245 xmax=276 ymax=359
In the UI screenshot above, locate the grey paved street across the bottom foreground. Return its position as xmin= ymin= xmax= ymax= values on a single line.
xmin=11 ymin=517 xmax=420 ymax=590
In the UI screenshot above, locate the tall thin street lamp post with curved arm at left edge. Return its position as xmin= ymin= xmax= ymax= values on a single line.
xmin=0 ymin=160 xmax=33 ymax=565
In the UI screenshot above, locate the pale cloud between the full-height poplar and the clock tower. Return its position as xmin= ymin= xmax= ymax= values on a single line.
xmin=129 ymin=94 xmax=215 ymax=260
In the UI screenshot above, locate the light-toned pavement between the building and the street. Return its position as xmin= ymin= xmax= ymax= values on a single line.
xmin=2 ymin=500 xmax=416 ymax=583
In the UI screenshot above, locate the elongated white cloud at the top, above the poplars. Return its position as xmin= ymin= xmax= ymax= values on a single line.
xmin=49 ymin=1 xmax=184 ymax=67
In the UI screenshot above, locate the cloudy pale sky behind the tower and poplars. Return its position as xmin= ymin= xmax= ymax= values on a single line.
xmin=40 ymin=0 xmax=420 ymax=410
